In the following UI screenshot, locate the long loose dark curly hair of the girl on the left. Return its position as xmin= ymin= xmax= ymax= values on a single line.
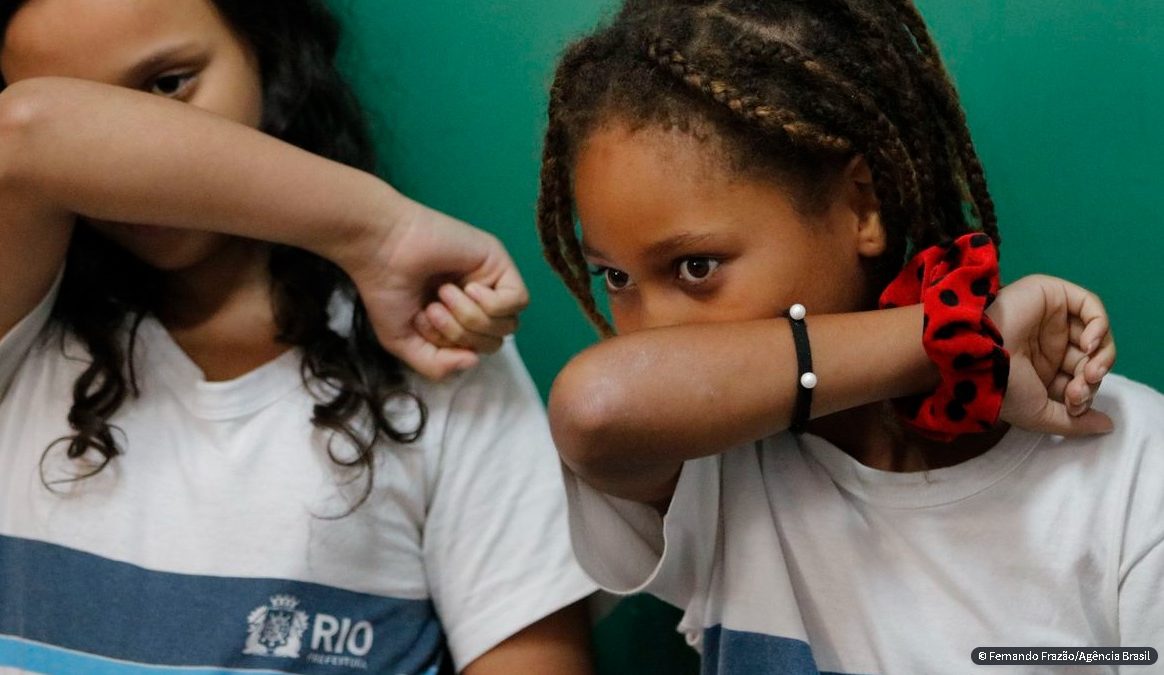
xmin=0 ymin=0 xmax=427 ymax=512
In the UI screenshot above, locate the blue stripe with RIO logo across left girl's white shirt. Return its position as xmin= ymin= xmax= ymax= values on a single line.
xmin=0 ymin=537 xmax=448 ymax=675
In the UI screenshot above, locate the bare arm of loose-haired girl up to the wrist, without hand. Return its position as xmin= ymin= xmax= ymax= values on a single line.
xmin=0 ymin=78 xmax=388 ymax=332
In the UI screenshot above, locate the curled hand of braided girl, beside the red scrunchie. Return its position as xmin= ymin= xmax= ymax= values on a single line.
xmin=986 ymin=275 xmax=1115 ymax=435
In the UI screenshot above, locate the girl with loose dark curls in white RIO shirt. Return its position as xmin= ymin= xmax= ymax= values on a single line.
xmin=0 ymin=0 xmax=594 ymax=675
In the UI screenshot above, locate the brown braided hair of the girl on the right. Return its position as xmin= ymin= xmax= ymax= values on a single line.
xmin=538 ymin=0 xmax=999 ymax=335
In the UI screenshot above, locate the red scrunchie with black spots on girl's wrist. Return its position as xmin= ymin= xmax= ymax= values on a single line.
xmin=880 ymin=233 xmax=1010 ymax=441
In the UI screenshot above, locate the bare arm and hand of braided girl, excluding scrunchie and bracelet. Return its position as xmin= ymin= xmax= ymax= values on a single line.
xmin=549 ymin=275 xmax=1116 ymax=505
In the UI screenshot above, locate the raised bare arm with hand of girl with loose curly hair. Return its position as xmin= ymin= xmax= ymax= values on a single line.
xmin=0 ymin=78 xmax=525 ymax=375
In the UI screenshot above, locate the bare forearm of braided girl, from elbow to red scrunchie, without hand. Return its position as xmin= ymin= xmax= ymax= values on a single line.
xmin=549 ymin=306 xmax=937 ymax=503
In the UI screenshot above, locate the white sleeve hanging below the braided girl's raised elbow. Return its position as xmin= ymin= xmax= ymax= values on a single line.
xmin=563 ymin=455 xmax=723 ymax=612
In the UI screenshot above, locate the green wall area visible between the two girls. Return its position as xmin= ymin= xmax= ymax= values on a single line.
xmin=333 ymin=0 xmax=609 ymax=395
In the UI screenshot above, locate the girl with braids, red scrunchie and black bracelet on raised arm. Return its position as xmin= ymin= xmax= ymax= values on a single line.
xmin=538 ymin=0 xmax=1164 ymax=674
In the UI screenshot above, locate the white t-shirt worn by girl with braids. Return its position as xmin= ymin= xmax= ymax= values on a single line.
xmin=567 ymin=376 xmax=1164 ymax=675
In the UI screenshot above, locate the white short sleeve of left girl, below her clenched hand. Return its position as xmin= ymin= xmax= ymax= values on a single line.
xmin=424 ymin=340 xmax=596 ymax=670
